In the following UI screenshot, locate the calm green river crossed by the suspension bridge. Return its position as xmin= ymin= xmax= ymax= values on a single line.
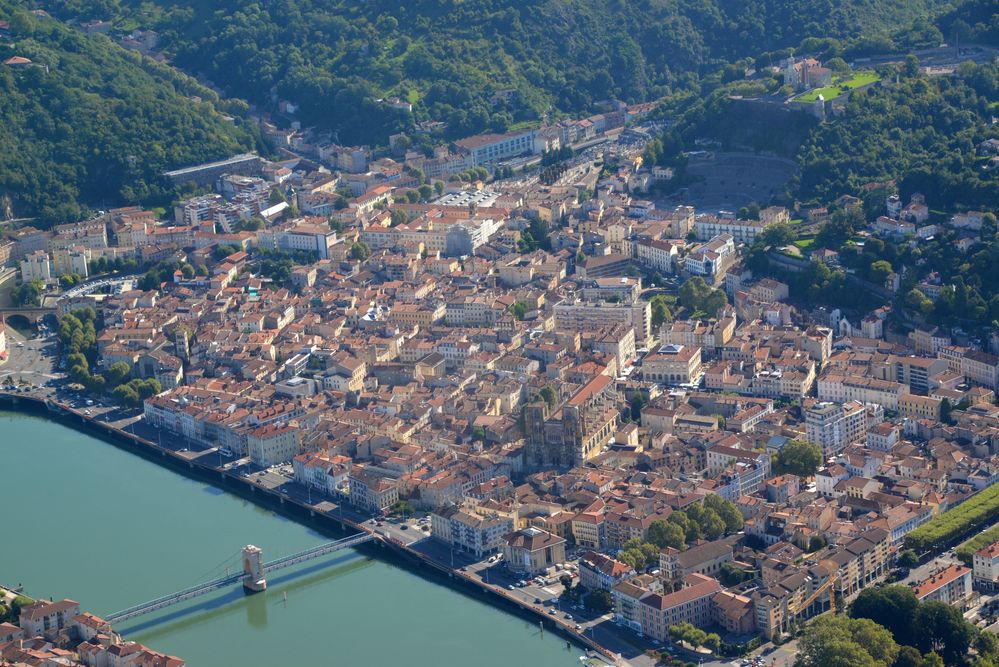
xmin=0 ymin=411 xmax=580 ymax=667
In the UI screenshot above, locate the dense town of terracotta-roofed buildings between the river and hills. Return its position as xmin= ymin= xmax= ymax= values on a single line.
xmin=7 ymin=121 xmax=999 ymax=652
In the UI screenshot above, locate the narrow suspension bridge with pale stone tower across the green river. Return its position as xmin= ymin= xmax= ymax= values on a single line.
xmin=104 ymin=533 xmax=375 ymax=624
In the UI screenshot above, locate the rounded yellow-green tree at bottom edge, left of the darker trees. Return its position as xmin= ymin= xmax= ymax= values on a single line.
xmin=794 ymin=616 xmax=899 ymax=667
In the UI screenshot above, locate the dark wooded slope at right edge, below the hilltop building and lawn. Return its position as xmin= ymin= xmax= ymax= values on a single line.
xmin=798 ymin=63 xmax=999 ymax=210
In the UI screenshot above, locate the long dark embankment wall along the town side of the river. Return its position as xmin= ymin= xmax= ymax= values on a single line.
xmin=0 ymin=394 xmax=616 ymax=661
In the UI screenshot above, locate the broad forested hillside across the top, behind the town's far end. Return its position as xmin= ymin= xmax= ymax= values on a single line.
xmin=52 ymin=0 xmax=952 ymax=143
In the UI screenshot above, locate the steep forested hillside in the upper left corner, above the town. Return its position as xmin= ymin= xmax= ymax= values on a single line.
xmin=0 ymin=0 xmax=259 ymax=223
